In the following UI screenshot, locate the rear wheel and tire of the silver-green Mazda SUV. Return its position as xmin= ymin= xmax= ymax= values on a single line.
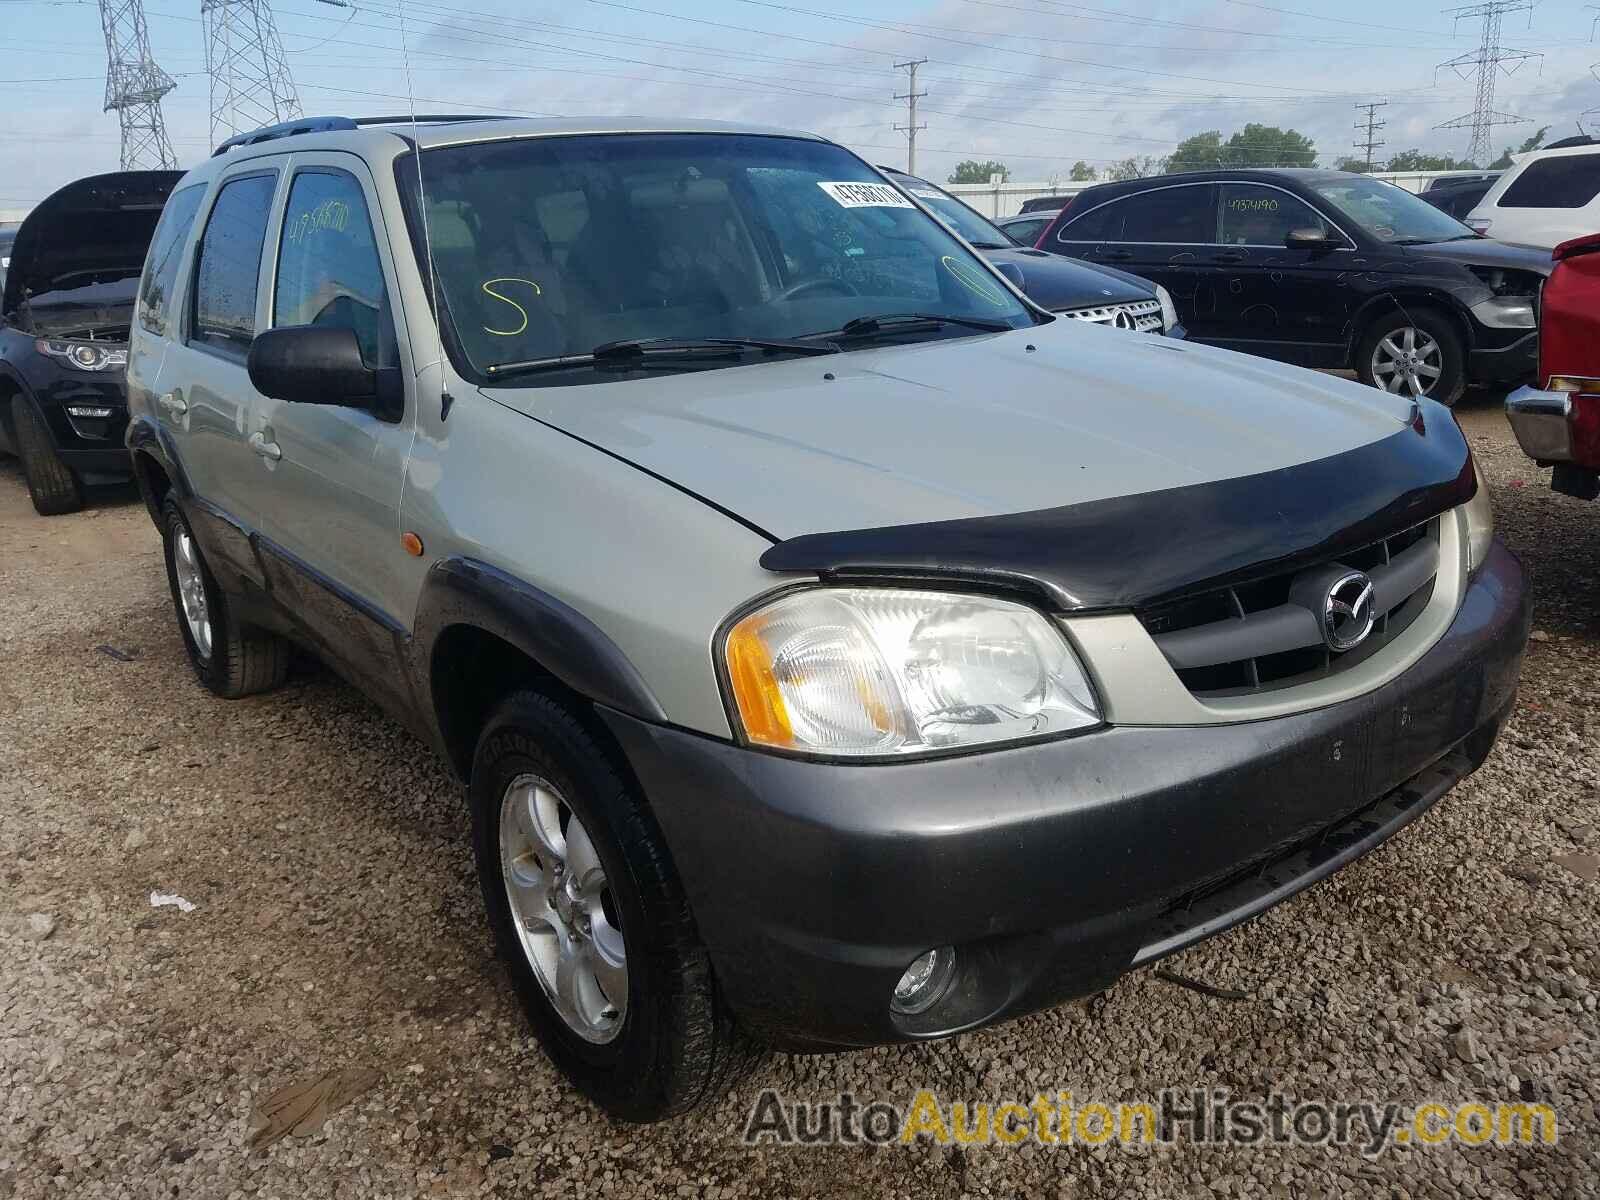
xmin=162 ymin=496 xmax=290 ymax=699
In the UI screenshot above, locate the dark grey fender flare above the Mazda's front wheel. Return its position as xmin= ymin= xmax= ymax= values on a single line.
xmin=411 ymin=557 xmax=667 ymax=723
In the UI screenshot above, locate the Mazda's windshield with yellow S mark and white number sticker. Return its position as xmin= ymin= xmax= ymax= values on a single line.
xmin=395 ymin=134 xmax=1032 ymax=384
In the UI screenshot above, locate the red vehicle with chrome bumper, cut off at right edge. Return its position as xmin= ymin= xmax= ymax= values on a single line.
xmin=1506 ymin=234 xmax=1600 ymax=499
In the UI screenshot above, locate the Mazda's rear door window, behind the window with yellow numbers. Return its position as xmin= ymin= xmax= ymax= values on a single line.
xmin=190 ymin=173 xmax=278 ymax=355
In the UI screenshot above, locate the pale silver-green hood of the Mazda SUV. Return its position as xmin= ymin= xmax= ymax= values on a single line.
xmin=485 ymin=320 xmax=1413 ymax=539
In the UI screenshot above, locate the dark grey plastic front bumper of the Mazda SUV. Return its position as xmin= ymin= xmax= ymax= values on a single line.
xmin=605 ymin=542 xmax=1530 ymax=1048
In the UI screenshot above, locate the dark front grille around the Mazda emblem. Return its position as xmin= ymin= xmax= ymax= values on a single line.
xmin=1139 ymin=520 xmax=1438 ymax=696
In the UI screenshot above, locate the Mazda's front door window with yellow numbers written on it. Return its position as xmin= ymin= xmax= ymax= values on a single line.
xmin=272 ymin=170 xmax=397 ymax=368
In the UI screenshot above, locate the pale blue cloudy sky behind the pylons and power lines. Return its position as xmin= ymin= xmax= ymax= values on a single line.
xmin=0 ymin=0 xmax=1600 ymax=206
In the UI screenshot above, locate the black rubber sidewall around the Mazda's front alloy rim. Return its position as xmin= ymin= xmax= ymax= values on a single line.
xmin=470 ymin=693 xmax=688 ymax=1120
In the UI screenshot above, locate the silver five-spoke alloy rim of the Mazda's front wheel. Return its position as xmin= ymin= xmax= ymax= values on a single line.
xmin=499 ymin=774 xmax=627 ymax=1043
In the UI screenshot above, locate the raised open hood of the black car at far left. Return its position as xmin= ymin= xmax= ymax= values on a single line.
xmin=0 ymin=171 xmax=182 ymax=326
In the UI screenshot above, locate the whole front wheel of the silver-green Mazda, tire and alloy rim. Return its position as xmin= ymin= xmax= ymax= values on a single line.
xmin=470 ymin=691 xmax=749 ymax=1122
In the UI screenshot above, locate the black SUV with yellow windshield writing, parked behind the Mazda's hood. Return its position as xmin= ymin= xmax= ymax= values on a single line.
xmin=1038 ymin=170 xmax=1550 ymax=403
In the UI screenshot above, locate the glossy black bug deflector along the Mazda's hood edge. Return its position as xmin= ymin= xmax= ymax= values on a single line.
xmin=762 ymin=400 xmax=1477 ymax=613
